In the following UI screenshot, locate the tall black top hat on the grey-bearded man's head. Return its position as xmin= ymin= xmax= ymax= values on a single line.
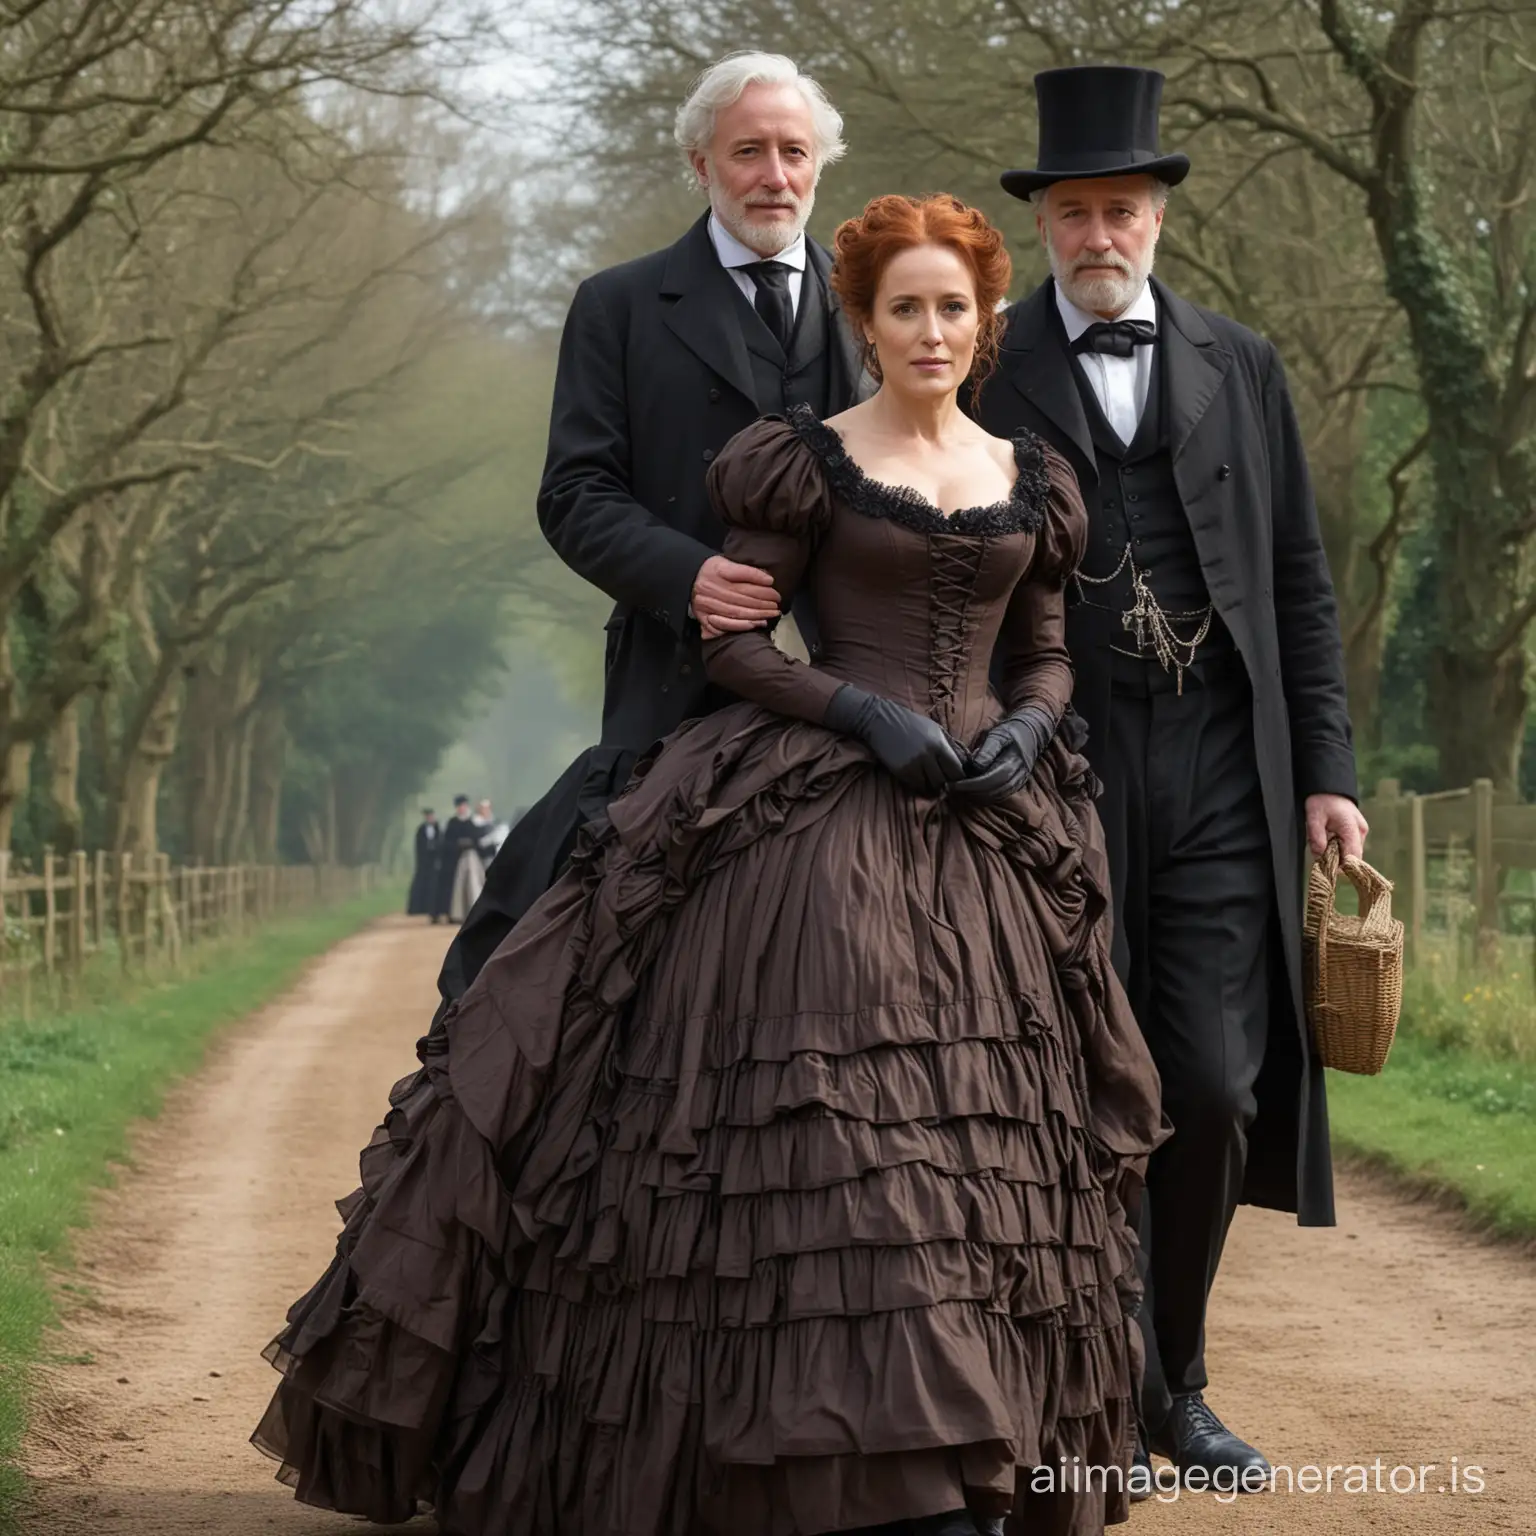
xmin=1001 ymin=65 xmax=1189 ymax=198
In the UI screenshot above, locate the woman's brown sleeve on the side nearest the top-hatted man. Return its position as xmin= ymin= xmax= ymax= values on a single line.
xmin=997 ymin=439 xmax=1087 ymax=719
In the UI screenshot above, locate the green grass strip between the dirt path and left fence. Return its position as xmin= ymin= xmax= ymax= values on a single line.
xmin=0 ymin=888 xmax=401 ymax=1530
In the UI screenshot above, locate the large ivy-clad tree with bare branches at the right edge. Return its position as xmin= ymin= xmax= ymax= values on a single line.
xmin=1172 ymin=0 xmax=1536 ymax=790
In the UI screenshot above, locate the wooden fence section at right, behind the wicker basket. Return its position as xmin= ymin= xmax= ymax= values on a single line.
xmin=1361 ymin=779 xmax=1536 ymax=958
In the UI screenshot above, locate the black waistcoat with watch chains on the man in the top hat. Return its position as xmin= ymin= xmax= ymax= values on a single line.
xmin=1072 ymin=330 xmax=1230 ymax=657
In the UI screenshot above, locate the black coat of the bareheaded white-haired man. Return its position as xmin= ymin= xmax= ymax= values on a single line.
xmin=438 ymin=214 xmax=862 ymax=1012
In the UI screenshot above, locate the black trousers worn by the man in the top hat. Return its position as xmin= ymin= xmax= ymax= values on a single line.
xmin=1100 ymin=653 xmax=1284 ymax=1430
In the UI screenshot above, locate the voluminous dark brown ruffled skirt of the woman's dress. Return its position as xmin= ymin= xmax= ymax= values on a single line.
xmin=253 ymin=705 xmax=1160 ymax=1536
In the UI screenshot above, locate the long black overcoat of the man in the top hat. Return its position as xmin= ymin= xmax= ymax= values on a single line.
xmin=974 ymin=278 xmax=1356 ymax=1226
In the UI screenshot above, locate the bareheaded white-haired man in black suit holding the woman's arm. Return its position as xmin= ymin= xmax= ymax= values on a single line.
xmin=438 ymin=52 xmax=862 ymax=1021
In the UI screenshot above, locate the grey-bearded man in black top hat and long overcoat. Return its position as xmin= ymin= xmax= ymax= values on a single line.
xmin=974 ymin=68 xmax=1366 ymax=1484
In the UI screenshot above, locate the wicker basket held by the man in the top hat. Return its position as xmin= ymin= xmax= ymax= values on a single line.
xmin=1303 ymin=839 xmax=1402 ymax=1075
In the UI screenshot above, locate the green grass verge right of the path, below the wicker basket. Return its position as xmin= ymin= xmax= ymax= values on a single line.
xmin=1329 ymin=1032 xmax=1536 ymax=1241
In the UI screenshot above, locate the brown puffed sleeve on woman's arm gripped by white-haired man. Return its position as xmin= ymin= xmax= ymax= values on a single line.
xmin=703 ymin=416 xmax=842 ymax=725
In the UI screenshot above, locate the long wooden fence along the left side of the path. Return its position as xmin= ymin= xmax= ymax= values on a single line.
xmin=0 ymin=849 xmax=379 ymax=1009
